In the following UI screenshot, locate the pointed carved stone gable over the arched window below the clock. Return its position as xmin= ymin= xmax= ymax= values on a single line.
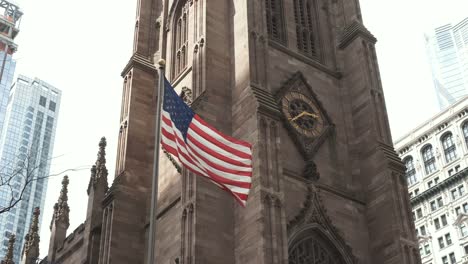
xmin=287 ymin=183 xmax=357 ymax=264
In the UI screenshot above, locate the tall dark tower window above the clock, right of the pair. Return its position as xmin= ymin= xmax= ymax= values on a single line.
xmin=294 ymin=0 xmax=318 ymax=59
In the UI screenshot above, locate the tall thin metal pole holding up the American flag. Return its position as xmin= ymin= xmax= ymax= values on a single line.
xmin=146 ymin=59 xmax=166 ymax=264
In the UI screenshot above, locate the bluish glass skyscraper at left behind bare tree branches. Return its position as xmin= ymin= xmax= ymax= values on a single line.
xmin=0 ymin=75 xmax=61 ymax=263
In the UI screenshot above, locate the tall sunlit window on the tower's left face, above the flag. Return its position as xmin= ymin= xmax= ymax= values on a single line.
xmin=172 ymin=1 xmax=188 ymax=79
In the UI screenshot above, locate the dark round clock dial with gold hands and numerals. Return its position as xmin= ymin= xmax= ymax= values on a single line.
xmin=281 ymin=92 xmax=323 ymax=138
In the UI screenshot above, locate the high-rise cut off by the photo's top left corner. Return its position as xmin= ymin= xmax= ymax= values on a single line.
xmin=0 ymin=0 xmax=23 ymax=138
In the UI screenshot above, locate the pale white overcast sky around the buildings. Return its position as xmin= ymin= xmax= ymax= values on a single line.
xmin=5 ymin=0 xmax=468 ymax=257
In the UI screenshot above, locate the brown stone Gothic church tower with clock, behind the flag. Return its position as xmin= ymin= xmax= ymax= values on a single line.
xmin=42 ymin=0 xmax=420 ymax=264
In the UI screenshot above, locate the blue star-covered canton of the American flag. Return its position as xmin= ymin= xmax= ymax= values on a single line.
xmin=163 ymin=79 xmax=195 ymax=142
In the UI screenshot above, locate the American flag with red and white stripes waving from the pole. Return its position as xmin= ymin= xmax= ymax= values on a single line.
xmin=161 ymin=80 xmax=252 ymax=206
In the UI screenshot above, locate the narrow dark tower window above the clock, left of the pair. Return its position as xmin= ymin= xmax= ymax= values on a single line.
xmin=265 ymin=0 xmax=286 ymax=43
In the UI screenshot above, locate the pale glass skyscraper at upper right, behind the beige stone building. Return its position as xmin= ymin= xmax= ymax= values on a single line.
xmin=425 ymin=17 xmax=468 ymax=110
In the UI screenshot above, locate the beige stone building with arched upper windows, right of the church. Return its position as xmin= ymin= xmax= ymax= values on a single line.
xmin=395 ymin=96 xmax=468 ymax=264
